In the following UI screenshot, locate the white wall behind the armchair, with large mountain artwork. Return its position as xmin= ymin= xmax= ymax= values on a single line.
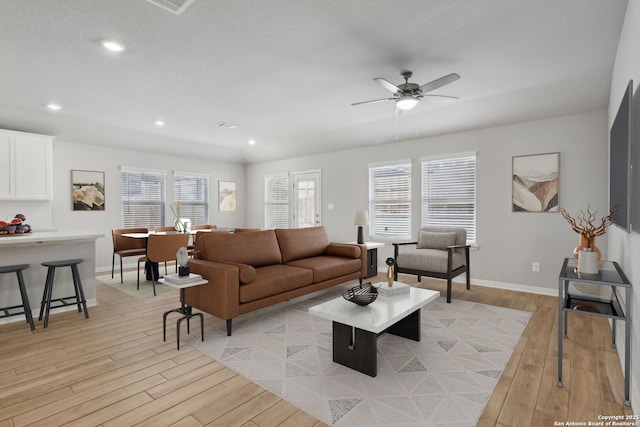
xmin=247 ymin=111 xmax=608 ymax=295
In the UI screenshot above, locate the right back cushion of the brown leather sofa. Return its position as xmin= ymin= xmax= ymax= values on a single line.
xmin=275 ymin=227 xmax=329 ymax=264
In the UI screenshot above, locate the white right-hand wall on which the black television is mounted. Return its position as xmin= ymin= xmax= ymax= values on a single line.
xmin=607 ymin=0 xmax=640 ymax=413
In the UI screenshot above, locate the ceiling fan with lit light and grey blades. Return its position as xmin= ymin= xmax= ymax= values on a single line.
xmin=351 ymin=71 xmax=460 ymax=110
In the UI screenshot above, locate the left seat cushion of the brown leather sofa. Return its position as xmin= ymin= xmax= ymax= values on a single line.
xmin=240 ymin=264 xmax=313 ymax=304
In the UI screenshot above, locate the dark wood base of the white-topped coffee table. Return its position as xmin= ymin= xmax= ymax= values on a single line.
xmin=333 ymin=309 xmax=420 ymax=377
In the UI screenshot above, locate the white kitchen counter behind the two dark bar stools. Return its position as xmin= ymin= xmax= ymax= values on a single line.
xmin=0 ymin=230 xmax=104 ymax=329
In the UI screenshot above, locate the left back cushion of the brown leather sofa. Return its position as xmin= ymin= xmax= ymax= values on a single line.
xmin=200 ymin=230 xmax=282 ymax=267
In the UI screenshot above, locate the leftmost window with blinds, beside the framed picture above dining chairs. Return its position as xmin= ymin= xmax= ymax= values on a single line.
xmin=121 ymin=167 xmax=165 ymax=229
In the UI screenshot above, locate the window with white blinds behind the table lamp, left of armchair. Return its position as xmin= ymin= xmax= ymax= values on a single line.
xmin=369 ymin=161 xmax=411 ymax=240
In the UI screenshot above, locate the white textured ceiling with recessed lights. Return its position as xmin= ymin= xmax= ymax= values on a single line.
xmin=0 ymin=0 xmax=627 ymax=163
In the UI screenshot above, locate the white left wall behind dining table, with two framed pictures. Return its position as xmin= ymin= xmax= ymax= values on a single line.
xmin=47 ymin=139 xmax=246 ymax=271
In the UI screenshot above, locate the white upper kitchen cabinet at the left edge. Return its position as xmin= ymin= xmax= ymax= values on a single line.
xmin=0 ymin=129 xmax=54 ymax=200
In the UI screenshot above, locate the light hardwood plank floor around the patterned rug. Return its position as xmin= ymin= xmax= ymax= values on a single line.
xmin=0 ymin=276 xmax=633 ymax=427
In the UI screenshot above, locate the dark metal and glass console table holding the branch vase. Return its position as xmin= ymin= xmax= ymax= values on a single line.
xmin=557 ymin=258 xmax=632 ymax=406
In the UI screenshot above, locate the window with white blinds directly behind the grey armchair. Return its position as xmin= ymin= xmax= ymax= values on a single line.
xmin=421 ymin=153 xmax=476 ymax=244
